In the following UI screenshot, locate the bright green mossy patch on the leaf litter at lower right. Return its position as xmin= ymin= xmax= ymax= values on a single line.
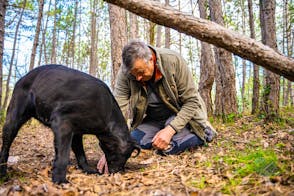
xmin=209 ymin=148 xmax=287 ymax=194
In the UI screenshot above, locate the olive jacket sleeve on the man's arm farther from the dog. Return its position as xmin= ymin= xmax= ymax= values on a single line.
xmin=169 ymin=56 xmax=207 ymax=132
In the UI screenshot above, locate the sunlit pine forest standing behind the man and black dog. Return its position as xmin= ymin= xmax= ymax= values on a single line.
xmin=0 ymin=0 xmax=294 ymax=120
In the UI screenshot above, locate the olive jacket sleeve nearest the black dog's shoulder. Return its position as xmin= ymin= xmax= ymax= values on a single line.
xmin=114 ymin=68 xmax=130 ymax=120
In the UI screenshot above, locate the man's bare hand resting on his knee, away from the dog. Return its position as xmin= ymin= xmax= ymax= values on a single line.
xmin=152 ymin=125 xmax=176 ymax=150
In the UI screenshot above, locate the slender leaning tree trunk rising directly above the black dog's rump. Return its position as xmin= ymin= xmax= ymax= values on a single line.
xmin=30 ymin=0 xmax=44 ymax=70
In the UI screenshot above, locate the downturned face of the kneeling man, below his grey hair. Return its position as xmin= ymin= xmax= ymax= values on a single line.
xmin=131 ymin=59 xmax=154 ymax=82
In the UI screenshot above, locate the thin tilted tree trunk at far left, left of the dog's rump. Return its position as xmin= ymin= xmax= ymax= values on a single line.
xmin=3 ymin=0 xmax=27 ymax=109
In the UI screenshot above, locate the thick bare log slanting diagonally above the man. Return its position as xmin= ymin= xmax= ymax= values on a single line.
xmin=105 ymin=0 xmax=294 ymax=81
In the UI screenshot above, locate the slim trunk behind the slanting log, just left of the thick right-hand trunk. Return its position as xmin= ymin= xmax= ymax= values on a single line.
xmin=248 ymin=0 xmax=259 ymax=114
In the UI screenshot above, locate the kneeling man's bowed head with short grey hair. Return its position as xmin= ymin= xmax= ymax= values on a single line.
xmin=122 ymin=40 xmax=154 ymax=82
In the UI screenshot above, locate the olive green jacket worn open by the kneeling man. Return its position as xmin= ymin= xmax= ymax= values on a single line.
xmin=114 ymin=46 xmax=214 ymax=141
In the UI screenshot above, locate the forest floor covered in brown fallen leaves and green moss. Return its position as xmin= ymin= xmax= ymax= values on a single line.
xmin=0 ymin=108 xmax=294 ymax=196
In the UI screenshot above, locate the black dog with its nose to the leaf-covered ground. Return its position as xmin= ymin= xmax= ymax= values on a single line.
xmin=0 ymin=65 xmax=140 ymax=183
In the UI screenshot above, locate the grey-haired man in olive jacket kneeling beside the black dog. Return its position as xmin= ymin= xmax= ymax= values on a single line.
xmin=97 ymin=40 xmax=216 ymax=171
